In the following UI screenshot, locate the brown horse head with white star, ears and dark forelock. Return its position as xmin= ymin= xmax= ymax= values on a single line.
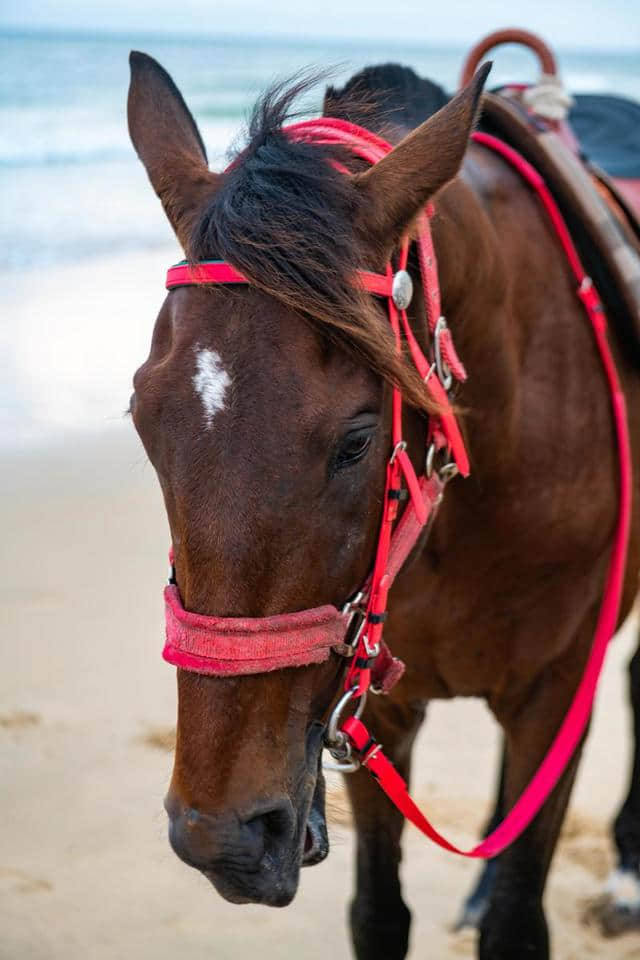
xmin=129 ymin=54 xmax=485 ymax=905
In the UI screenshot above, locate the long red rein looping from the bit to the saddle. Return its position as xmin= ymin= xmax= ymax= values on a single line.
xmin=342 ymin=133 xmax=631 ymax=858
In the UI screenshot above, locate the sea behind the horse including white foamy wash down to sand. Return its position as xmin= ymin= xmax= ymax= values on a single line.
xmin=0 ymin=25 xmax=640 ymax=444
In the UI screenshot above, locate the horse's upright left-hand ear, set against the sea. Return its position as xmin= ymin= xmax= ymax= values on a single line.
xmin=127 ymin=50 xmax=220 ymax=253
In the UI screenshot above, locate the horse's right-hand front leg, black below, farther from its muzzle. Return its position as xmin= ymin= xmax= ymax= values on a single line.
xmin=479 ymin=648 xmax=592 ymax=960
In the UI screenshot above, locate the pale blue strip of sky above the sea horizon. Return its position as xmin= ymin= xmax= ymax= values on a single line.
xmin=0 ymin=0 xmax=640 ymax=56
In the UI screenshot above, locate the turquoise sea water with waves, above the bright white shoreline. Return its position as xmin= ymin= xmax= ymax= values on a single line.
xmin=0 ymin=33 xmax=640 ymax=269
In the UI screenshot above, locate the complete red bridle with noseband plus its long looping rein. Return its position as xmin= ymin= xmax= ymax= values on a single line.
xmin=163 ymin=118 xmax=631 ymax=857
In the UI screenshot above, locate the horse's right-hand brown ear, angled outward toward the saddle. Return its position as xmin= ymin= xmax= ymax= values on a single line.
xmin=356 ymin=63 xmax=491 ymax=258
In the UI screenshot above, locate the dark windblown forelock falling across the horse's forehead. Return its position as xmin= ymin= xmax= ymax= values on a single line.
xmin=188 ymin=70 xmax=442 ymax=411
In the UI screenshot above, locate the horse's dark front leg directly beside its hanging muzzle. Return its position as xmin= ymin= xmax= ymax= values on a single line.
xmin=346 ymin=698 xmax=425 ymax=960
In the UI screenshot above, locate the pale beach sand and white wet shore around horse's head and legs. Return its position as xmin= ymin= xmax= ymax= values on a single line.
xmin=0 ymin=253 xmax=640 ymax=960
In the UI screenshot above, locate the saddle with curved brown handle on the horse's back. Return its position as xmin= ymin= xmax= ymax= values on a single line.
xmin=464 ymin=36 xmax=640 ymax=364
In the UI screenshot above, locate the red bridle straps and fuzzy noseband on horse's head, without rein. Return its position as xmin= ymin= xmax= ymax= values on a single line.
xmin=163 ymin=118 xmax=469 ymax=696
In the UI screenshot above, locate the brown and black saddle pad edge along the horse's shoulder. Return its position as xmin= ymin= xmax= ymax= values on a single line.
xmin=480 ymin=93 xmax=640 ymax=364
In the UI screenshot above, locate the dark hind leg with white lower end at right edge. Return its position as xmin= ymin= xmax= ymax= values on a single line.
xmin=600 ymin=628 xmax=640 ymax=935
